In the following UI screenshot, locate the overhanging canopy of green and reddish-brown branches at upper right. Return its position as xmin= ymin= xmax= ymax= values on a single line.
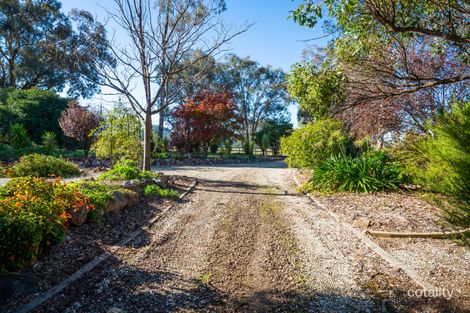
xmin=292 ymin=0 xmax=470 ymax=137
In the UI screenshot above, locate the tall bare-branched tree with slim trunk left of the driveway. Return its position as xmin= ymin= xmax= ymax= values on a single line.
xmin=95 ymin=0 xmax=249 ymax=170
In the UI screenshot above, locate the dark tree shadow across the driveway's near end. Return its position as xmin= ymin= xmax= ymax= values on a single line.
xmin=29 ymin=257 xmax=468 ymax=313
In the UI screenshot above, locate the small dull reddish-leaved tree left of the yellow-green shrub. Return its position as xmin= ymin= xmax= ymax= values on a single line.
xmin=59 ymin=101 xmax=100 ymax=156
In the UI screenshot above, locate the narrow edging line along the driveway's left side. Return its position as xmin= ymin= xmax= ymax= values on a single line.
xmin=15 ymin=180 xmax=197 ymax=313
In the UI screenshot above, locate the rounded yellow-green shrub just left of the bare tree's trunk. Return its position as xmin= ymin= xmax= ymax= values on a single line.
xmin=92 ymin=109 xmax=143 ymax=163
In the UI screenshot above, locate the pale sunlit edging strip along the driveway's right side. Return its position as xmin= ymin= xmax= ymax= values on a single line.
xmin=293 ymin=171 xmax=437 ymax=290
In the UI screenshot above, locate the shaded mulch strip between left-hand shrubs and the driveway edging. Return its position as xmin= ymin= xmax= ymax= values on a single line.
xmin=0 ymin=177 xmax=194 ymax=312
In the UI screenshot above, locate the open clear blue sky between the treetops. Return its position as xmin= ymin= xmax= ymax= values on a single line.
xmin=62 ymin=0 xmax=328 ymax=125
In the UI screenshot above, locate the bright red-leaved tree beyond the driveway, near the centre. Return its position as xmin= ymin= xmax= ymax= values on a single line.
xmin=171 ymin=90 xmax=237 ymax=153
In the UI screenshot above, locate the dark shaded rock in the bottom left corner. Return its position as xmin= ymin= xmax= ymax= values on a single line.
xmin=0 ymin=273 xmax=38 ymax=303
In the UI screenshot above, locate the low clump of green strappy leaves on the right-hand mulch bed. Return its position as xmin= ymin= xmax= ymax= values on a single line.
xmin=310 ymin=151 xmax=407 ymax=192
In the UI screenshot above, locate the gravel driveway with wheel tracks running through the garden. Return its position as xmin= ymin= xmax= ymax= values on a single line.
xmin=31 ymin=162 xmax=465 ymax=312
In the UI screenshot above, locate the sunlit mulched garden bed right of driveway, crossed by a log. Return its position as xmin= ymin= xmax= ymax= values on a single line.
xmin=297 ymin=171 xmax=470 ymax=305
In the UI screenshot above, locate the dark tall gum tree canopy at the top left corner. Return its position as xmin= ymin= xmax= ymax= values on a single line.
xmin=0 ymin=0 xmax=114 ymax=97
